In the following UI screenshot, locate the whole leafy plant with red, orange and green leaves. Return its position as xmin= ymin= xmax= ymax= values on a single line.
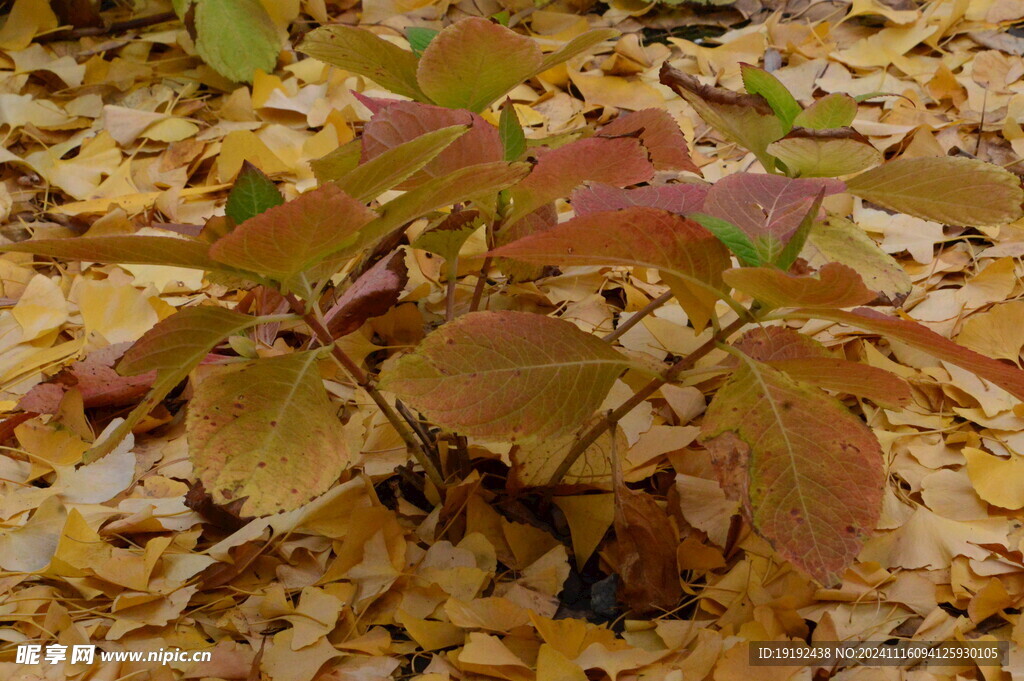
xmin=3 ymin=14 xmax=1024 ymax=587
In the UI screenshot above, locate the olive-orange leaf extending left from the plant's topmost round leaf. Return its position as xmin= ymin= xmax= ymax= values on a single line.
xmin=298 ymin=24 xmax=430 ymax=101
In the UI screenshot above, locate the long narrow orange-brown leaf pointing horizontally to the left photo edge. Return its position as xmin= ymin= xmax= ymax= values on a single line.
xmin=0 ymin=236 xmax=259 ymax=281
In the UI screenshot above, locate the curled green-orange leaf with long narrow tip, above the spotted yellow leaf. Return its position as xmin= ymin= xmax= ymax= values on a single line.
xmin=84 ymin=307 xmax=268 ymax=462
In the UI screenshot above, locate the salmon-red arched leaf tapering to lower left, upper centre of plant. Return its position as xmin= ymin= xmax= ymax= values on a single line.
xmin=506 ymin=137 xmax=654 ymax=224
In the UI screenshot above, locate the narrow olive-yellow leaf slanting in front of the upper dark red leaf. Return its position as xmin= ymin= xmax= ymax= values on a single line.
xmin=336 ymin=125 xmax=469 ymax=202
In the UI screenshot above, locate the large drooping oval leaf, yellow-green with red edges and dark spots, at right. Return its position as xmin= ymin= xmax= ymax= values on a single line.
xmin=701 ymin=359 xmax=885 ymax=585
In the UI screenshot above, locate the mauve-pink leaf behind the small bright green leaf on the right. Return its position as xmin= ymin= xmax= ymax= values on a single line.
xmin=701 ymin=173 xmax=844 ymax=244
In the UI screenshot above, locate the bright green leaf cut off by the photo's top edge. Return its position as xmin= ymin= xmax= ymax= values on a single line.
xmin=196 ymin=0 xmax=281 ymax=83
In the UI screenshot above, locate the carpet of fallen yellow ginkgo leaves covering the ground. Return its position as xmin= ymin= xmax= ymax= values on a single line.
xmin=0 ymin=0 xmax=1024 ymax=681
